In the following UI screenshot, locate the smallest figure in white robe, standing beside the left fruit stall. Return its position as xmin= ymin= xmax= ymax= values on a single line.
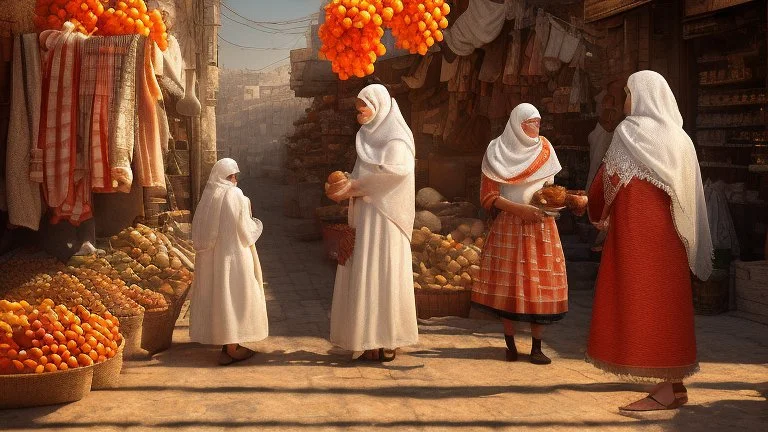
xmin=189 ymin=159 xmax=269 ymax=365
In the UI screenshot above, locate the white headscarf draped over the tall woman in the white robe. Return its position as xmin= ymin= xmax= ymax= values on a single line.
xmin=352 ymin=84 xmax=416 ymax=239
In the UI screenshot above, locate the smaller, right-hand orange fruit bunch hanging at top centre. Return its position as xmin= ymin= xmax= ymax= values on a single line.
xmin=390 ymin=0 xmax=451 ymax=55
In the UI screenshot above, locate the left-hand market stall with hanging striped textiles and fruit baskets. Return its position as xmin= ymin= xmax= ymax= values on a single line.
xmin=0 ymin=0 xmax=199 ymax=408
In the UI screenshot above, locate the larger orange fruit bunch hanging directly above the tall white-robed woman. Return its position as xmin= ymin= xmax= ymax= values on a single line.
xmin=319 ymin=0 xmax=392 ymax=80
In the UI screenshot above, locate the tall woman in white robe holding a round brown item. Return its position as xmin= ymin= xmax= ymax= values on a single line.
xmin=330 ymin=84 xmax=419 ymax=361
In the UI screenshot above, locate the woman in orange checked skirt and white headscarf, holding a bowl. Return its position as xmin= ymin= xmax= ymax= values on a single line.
xmin=472 ymin=103 xmax=568 ymax=364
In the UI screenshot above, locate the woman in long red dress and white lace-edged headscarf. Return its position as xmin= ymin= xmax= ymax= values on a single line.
xmin=587 ymin=71 xmax=712 ymax=411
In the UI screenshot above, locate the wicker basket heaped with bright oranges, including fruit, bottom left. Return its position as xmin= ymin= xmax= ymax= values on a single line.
xmin=0 ymin=299 xmax=121 ymax=408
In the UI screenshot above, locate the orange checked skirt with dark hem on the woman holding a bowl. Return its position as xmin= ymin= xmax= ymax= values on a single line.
xmin=472 ymin=212 xmax=568 ymax=324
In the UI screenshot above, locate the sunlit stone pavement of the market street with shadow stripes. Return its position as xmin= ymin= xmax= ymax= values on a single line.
xmin=0 ymin=179 xmax=768 ymax=431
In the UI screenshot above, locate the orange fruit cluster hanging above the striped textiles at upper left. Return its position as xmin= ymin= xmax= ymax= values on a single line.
xmin=34 ymin=0 xmax=168 ymax=51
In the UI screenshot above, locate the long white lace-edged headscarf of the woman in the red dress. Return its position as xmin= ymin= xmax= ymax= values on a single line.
xmin=604 ymin=70 xmax=712 ymax=280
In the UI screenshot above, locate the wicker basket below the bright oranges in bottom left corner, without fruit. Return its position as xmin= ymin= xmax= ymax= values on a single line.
xmin=0 ymin=366 xmax=93 ymax=409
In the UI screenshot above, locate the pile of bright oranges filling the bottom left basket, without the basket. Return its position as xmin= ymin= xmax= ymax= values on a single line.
xmin=0 ymin=299 xmax=120 ymax=374
